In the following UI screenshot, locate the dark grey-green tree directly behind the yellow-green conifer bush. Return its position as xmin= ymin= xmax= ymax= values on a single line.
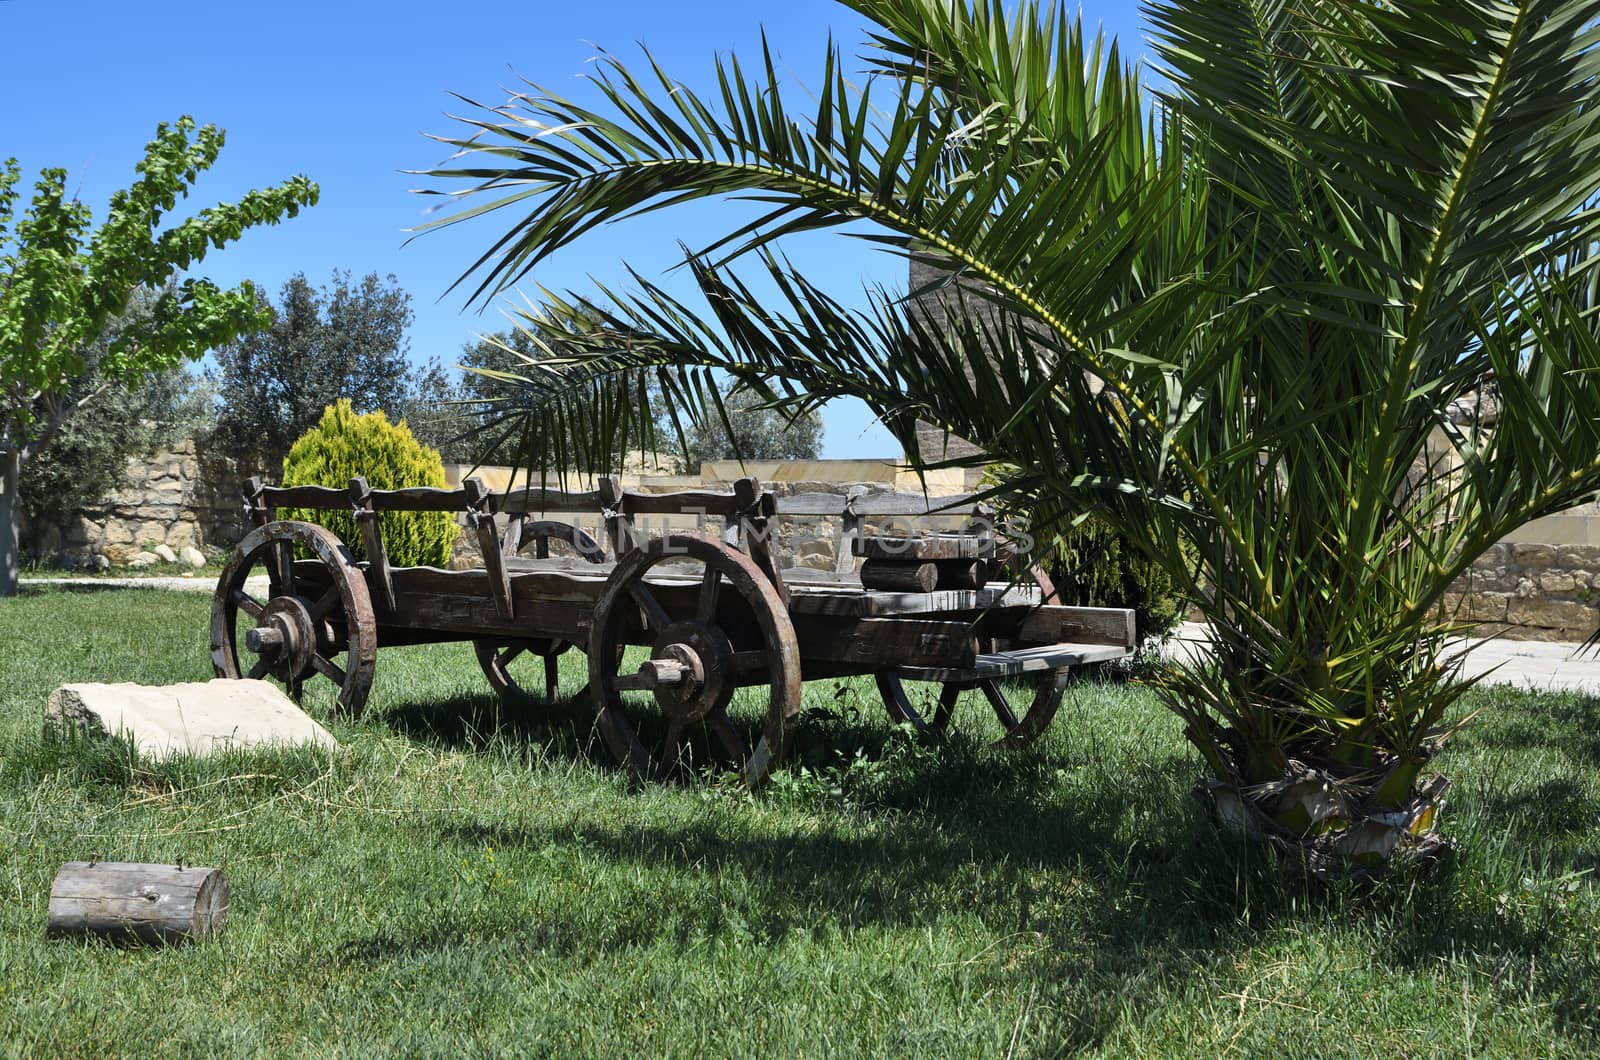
xmin=213 ymin=272 xmax=429 ymax=468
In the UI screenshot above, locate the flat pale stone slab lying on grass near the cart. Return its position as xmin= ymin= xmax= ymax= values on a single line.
xmin=45 ymin=679 xmax=339 ymax=759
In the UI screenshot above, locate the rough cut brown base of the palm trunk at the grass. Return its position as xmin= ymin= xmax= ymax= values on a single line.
xmin=1190 ymin=759 xmax=1451 ymax=881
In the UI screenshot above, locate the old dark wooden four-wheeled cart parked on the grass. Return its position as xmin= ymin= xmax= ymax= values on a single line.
xmin=211 ymin=479 xmax=1134 ymax=785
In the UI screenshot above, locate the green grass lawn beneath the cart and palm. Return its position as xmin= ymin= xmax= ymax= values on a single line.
xmin=0 ymin=588 xmax=1600 ymax=1057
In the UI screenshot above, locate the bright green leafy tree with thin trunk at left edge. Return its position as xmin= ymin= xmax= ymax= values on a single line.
xmin=0 ymin=117 xmax=317 ymax=596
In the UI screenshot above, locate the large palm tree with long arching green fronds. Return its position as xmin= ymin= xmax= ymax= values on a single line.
xmin=430 ymin=0 xmax=1600 ymax=873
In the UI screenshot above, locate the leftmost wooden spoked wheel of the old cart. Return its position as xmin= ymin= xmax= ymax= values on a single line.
xmin=211 ymin=520 xmax=378 ymax=716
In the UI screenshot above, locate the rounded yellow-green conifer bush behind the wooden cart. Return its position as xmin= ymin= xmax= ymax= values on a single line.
xmin=280 ymin=400 xmax=459 ymax=567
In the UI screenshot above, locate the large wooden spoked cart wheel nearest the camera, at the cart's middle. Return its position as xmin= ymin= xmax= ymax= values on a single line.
xmin=589 ymin=535 xmax=800 ymax=788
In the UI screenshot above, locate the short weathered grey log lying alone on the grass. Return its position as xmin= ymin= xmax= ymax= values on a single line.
xmin=45 ymin=861 xmax=227 ymax=945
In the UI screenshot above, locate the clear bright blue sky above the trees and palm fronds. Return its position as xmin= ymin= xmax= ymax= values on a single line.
xmin=0 ymin=0 xmax=1142 ymax=458
